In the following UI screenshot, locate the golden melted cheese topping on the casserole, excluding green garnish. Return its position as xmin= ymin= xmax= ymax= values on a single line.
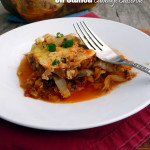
xmin=27 ymin=34 xmax=95 ymax=69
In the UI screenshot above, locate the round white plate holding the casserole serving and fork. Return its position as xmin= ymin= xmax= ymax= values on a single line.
xmin=0 ymin=18 xmax=150 ymax=130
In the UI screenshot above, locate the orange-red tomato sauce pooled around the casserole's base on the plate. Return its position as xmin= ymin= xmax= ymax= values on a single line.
xmin=17 ymin=57 xmax=118 ymax=103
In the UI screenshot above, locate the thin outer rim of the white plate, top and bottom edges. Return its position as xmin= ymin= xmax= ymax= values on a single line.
xmin=0 ymin=17 xmax=150 ymax=131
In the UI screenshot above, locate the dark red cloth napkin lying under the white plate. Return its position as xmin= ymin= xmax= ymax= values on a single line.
xmin=0 ymin=13 xmax=150 ymax=150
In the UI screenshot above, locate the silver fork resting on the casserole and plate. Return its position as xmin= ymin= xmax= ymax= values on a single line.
xmin=73 ymin=21 xmax=150 ymax=75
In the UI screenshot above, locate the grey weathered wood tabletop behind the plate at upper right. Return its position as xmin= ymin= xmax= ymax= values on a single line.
xmin=90 ymin=0 xmax=150 ymax=29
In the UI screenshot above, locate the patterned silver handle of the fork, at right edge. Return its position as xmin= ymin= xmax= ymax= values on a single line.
xmin=126 ymin=62 xmax=150 ymax=75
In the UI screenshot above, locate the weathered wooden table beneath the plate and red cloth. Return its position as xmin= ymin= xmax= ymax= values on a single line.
xmin=0 ymin=0 xmax=150 ymax=150
